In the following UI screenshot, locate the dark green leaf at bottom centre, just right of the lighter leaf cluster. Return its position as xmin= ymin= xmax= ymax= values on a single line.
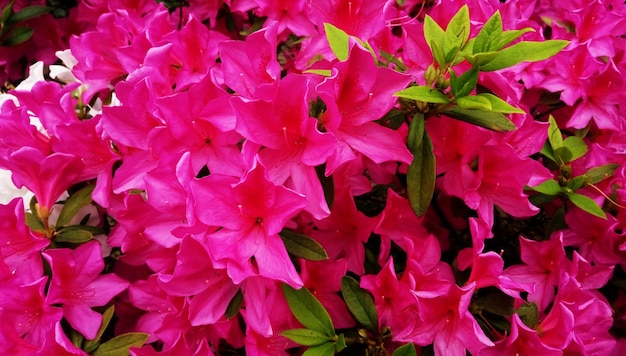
xmin=341 ymin=276 xmax=378 ymax=331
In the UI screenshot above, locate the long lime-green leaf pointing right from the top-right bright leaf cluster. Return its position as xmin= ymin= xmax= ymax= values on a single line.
xmin=480 ymin=40 xmax=569 ymax=72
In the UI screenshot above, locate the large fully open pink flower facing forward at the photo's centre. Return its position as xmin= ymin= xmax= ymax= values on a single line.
xmin=191 ymin=161 xmax=307 ymax=287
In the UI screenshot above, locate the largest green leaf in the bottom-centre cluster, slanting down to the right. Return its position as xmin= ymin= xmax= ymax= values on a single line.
xmin=283 ymin=284 xmax=335 ymax=337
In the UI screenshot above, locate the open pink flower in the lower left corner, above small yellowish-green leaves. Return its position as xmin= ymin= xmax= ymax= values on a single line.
xmin=43 ymin=241 xmax=128 ymax=339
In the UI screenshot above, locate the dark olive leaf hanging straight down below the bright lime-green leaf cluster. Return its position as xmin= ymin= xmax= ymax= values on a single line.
xmin=406 ymin=120 xmax=436 ymax=216
